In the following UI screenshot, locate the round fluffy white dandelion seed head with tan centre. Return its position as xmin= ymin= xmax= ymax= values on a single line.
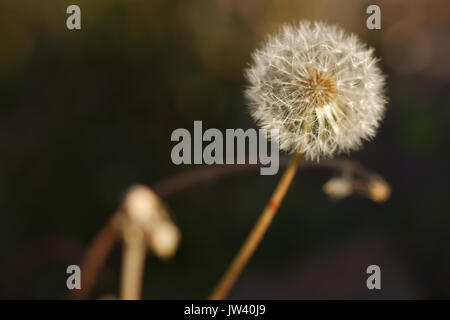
xmin=245 ymin=21 xmax=386 ymax=160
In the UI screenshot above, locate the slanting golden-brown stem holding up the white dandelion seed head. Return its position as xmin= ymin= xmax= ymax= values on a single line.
xmin=210 ymin=153 xmax=301 ymax=300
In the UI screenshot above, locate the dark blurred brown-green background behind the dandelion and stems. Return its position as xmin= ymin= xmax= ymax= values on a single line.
xmin=0 ymin=0 xmax=450 ymax=299
